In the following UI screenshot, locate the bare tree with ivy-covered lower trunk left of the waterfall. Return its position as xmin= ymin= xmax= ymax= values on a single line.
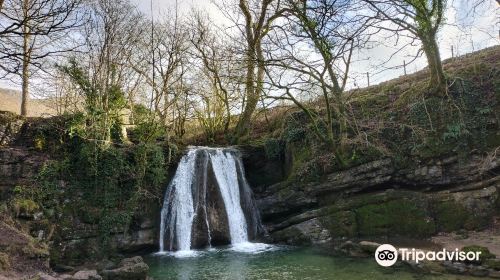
xmin=62 ymin=0 xmax=147 ymax=145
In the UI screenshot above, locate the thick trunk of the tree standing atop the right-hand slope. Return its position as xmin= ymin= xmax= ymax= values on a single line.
xmin=422 ymin=35 xmax=447 ymax=97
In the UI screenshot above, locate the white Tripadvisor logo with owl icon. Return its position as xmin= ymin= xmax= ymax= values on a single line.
xmin=375 ymin=244 xmax=481 ymax=267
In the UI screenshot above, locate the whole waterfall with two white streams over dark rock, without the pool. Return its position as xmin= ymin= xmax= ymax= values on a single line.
xmin=159 ymin=147 xmax=262 ymax=255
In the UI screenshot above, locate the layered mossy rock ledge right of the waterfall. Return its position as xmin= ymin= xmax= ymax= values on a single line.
xmin=247 ymin=144 xmax=500 ymax=247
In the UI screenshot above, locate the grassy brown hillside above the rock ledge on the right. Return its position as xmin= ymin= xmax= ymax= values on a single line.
xmin=239 ymin=46 xmax=500 ymax=180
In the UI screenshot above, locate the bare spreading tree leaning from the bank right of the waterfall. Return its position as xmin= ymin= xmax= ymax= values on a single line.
xmin=266 ymin=0 xmax=369 ymax=164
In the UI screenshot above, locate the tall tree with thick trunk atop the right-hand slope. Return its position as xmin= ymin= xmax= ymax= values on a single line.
xmin=363 ymin=0 xmax=447 ymax=96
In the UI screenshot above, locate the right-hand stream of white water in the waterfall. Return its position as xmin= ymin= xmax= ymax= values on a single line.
xmin=210 ymin=150 xmax=248 ymax=244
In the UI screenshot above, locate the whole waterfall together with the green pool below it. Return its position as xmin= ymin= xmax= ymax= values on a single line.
xmin=153 ymin=147 xmax=484 ymax=280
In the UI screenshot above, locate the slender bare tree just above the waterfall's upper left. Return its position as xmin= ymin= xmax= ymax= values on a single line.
xmin=129 ymin=11 xmax=190 ymax=141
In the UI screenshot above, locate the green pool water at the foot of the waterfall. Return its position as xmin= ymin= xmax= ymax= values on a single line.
xmin=146 ymin=247 xmax=484 ymax=280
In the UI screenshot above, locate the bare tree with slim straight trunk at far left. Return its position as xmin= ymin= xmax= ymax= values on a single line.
xmin=0 ymin=0 xmax=82 ymax=116
